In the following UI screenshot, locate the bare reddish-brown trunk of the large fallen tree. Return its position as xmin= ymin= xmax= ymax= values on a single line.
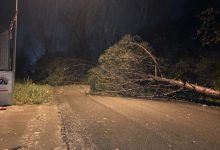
xmin=147 ymin=75 xmax=220 ymax=99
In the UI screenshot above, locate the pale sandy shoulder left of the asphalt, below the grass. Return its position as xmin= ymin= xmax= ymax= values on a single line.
xmin=0 ymin=104 xmax=65 ymax=149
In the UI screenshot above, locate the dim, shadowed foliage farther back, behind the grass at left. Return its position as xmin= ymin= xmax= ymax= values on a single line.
xmin=33 ymin=56 xmax=92 ymax=86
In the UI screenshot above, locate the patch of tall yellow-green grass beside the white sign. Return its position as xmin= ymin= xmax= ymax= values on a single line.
xmin=13 ymin=80 xmax=53 ymax=105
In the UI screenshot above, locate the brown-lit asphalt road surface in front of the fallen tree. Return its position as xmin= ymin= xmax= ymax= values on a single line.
xmin=55 ymin=86 xmax=220 ymax=150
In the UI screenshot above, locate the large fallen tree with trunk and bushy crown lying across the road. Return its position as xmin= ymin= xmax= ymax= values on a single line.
xmin=88 ymin=35 xmax=220 ymax=99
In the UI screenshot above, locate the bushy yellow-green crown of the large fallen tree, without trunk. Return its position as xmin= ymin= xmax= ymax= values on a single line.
xmin=88 ymin=35 xmax=165 ymax=97
